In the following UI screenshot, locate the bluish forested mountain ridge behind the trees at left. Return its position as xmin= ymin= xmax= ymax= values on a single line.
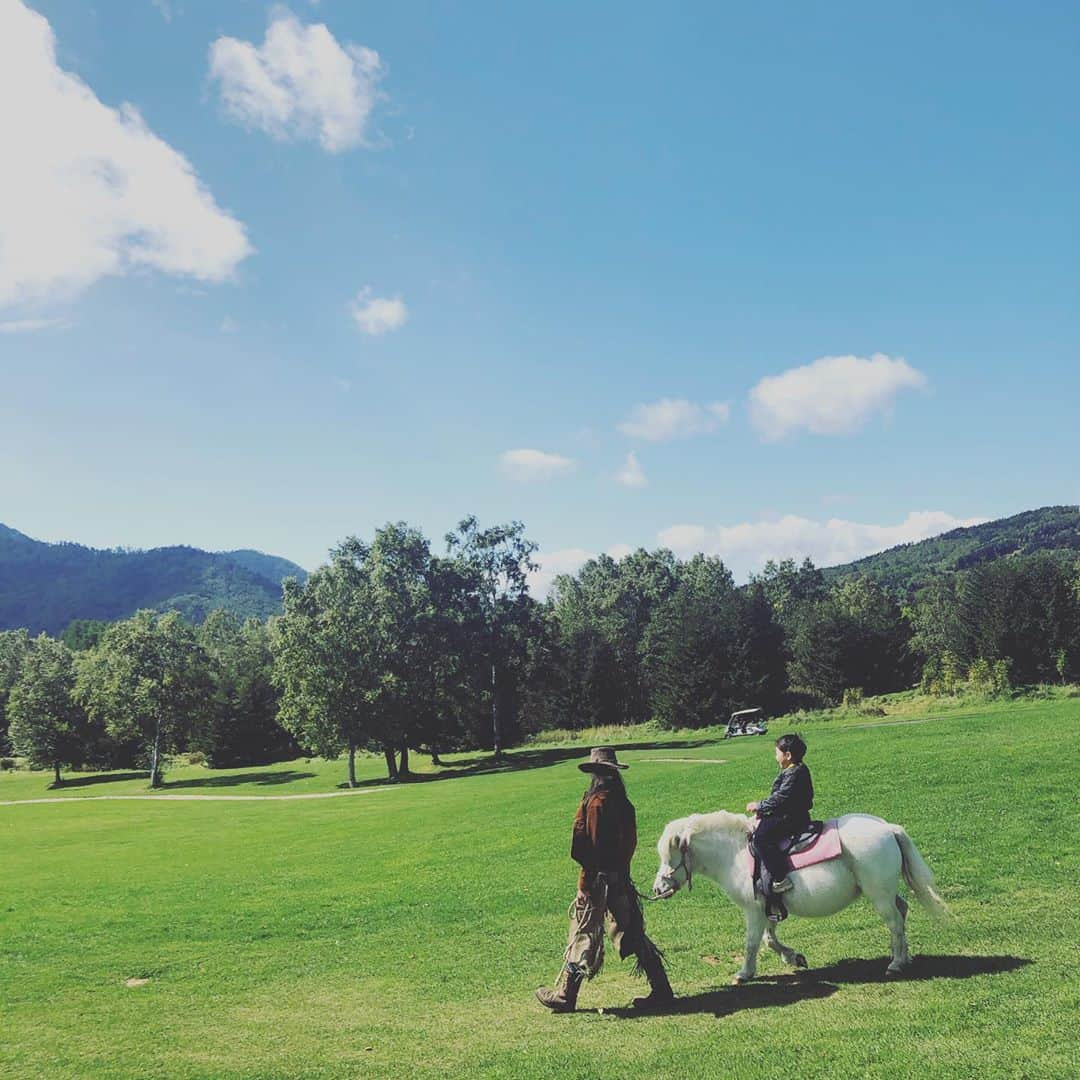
xmin=0 ymin=524 xmax=308 ymax=635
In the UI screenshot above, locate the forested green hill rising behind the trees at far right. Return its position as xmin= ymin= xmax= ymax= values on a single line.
xmin=824 ymin=507 xmax=1080 ymax=592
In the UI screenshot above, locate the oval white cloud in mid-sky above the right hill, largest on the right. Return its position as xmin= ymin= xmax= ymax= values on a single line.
xmin=750 ymin=352 xmax=927 ymax=441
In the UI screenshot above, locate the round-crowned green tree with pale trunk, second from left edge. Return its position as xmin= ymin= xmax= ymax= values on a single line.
xmin=76 ymin=611 xmax=213 ymax=787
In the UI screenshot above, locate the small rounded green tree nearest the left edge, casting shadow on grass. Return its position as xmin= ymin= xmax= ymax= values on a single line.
xmin=8 ymin=634 xmax=87 ymax=786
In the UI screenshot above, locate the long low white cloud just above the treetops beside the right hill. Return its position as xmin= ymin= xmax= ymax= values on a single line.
xmin=659 ymin=510 xmax=986 ymax=579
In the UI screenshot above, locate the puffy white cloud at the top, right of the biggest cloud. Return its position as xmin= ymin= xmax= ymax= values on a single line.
xmin=210 ymin=11 xmax=383 ymax=153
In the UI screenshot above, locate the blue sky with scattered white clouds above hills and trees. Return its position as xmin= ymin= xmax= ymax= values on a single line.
xmin=0 ymin=0 xmax=1080 ymax=586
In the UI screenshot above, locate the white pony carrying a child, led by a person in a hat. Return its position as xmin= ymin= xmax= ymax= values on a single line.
xmin=652 ymin=810 xmax=948 ymax=983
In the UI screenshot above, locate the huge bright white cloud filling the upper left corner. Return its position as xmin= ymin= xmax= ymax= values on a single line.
xmin=0 ymin=0 xmax=252 ymax=307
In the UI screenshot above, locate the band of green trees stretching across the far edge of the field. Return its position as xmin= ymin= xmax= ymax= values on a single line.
xmin=0 ymin=517 xmax=1080 ymax=786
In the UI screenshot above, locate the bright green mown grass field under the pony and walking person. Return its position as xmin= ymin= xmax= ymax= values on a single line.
xmin=0 ymin=699 xmax=1080 ymax=1080
